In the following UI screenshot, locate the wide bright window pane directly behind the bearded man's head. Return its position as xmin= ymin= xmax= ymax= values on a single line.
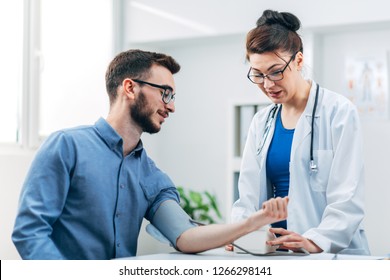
xmin=39 ymin=0 xmax=113 ymax=136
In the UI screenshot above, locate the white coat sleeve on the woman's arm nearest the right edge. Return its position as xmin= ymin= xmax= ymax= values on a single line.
xmin=312 ymin=104 xmax=364 ymax=254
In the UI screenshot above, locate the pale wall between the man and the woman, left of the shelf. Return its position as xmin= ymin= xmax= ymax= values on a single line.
xmin=136 ymin=34 xmax=272 ymax=254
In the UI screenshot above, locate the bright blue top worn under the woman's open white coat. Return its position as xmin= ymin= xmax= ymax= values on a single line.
xmin=266 ymin=109 xmax=294 ymax=229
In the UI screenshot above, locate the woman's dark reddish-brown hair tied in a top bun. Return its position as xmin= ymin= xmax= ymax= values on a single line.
xmin=246 ymin=10 xmax=303 ymax=60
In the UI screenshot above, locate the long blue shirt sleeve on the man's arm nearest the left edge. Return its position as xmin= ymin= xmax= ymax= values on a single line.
xmin=12 ymin=132 xmax=74 ymax=259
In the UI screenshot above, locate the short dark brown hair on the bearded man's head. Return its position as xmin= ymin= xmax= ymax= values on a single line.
xmin=106 ymin=50 xmax=180 ymax=104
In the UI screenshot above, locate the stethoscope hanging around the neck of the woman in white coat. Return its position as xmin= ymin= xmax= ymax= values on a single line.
xmin=256 ymin=84 xmax=320 ymax=172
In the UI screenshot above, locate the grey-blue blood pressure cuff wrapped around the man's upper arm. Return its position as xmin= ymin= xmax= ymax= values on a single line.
xmin=146 ymin=200 xmax=198 ymax=249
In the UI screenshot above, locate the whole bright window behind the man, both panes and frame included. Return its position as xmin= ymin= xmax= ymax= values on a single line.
xmin=0 ymin=0 xmax=113 ymax=148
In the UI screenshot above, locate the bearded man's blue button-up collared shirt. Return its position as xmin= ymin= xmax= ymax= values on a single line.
xmin=12 ymin=118 xmax=179 ymax=259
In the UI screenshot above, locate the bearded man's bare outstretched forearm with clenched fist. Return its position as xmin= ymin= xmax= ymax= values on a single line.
xmin=153 ymin=197 xmax=288 ymax=253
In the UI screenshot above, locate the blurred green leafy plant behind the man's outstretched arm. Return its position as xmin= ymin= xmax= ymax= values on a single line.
xmin=177 ymin=186 xmax=222 ymax=224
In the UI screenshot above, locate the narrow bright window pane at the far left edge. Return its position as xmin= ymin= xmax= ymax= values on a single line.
xmin=0 ymin=1 xmax=23 ymax=143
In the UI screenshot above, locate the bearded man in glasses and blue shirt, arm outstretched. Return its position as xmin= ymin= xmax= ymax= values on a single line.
xmin=12 ymin=50 xmax=288 ymax=259
